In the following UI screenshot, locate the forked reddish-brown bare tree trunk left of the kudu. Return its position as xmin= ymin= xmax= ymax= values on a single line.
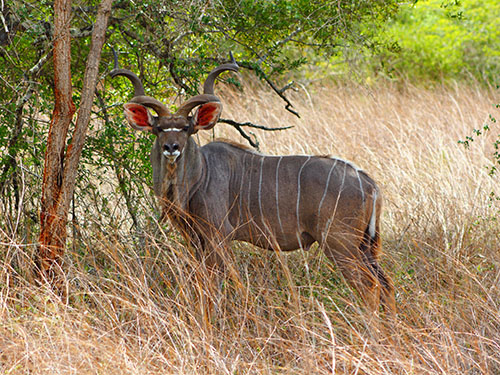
xmin=38 ymin=0 xmax=112 ymax=286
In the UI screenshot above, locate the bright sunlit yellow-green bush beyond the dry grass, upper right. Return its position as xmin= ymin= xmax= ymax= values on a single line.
xmin=372 ymin=0 xmax=500 ymax=84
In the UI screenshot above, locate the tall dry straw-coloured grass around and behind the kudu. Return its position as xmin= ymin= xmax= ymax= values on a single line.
xmin=0 ymin=81 xmax=500 ymax=374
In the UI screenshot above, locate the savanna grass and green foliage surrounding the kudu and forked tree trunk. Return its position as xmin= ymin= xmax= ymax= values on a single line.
xmin=0 ymin=0 xmax=500 ymax=374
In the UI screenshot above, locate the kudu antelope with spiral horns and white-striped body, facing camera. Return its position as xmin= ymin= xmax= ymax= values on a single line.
xmin=111 ymin=56 xmax=395 ymax=314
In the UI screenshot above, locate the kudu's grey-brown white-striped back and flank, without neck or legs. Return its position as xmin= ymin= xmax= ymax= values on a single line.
xmin=202 ymin=142 xmax=376 ymax=250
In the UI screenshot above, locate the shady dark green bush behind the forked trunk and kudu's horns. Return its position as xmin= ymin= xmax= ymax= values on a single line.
xmin=0 ymin=0 xmax=397 ymax=241
